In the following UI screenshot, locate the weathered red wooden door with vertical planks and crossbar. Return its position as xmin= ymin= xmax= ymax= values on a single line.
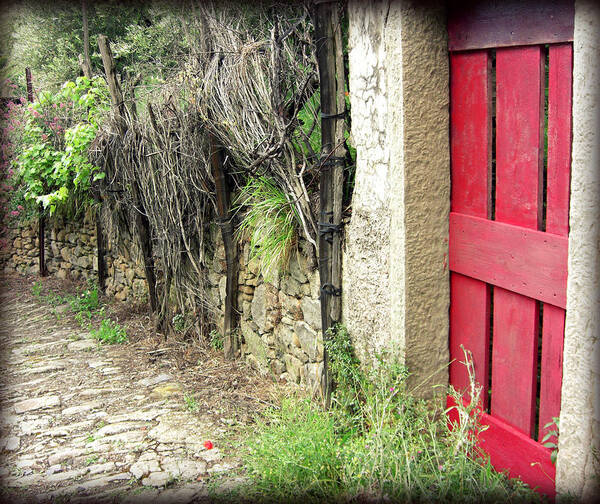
xmin=448 ymin=2 xmax=573 ymax=495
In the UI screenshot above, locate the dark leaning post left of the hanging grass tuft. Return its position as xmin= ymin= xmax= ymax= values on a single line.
xmin=208 ymin=132 xmax=239 ymax=359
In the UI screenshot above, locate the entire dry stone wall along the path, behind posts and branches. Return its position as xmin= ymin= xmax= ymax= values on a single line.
xmin=0 ymin=218 xmax=323 ymax=392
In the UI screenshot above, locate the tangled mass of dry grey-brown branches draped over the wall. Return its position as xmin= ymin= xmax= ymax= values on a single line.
xmin=92 ymin=2 xmax=319 ymax=336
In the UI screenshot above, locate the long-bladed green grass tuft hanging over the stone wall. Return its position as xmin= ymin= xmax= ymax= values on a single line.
xmin=235 ymin=177 xmax=300 ymax=281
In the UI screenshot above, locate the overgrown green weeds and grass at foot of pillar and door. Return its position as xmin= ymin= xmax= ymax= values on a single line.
xmin=244 ymin=327 xmax=540 ymax=502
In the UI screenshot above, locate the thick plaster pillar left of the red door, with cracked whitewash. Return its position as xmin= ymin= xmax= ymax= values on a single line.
xmin=343 ymin=0 xmax=450 ymax=396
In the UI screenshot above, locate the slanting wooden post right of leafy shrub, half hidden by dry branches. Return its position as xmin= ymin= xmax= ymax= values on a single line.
xmin=98 ymin=35 xmax=158 ymax=313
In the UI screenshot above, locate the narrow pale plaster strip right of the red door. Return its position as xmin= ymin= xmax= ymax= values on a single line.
xmin=556 ymin=1 xmax=600 ymax=502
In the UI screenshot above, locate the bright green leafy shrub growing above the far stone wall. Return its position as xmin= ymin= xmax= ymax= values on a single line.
xmin=6 ymin=77 xmax=108 ymax=218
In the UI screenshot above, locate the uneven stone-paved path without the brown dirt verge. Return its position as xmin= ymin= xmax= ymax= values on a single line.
xmin=0 ymin=282 xmax=262 ymax=502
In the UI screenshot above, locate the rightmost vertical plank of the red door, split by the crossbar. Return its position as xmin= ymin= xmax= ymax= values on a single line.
xmin=538 ymin=44 xmax=573 ymax=442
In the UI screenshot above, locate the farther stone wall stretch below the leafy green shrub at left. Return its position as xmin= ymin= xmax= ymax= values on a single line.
xmin=0 ymin=216 xmax=147 ymax=301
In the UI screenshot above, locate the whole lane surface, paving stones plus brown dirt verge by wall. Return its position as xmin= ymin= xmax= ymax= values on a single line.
xmin=0 ymin=275 xmax=284 ymax=502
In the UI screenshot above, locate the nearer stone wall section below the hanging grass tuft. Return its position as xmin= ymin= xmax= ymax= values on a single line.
xmin=209 ymin=226 xmax=323 ymax=392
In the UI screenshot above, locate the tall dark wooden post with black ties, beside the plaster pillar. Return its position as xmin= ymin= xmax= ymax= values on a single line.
xmin=314 ymin=0 xmax=346 ymax=406
